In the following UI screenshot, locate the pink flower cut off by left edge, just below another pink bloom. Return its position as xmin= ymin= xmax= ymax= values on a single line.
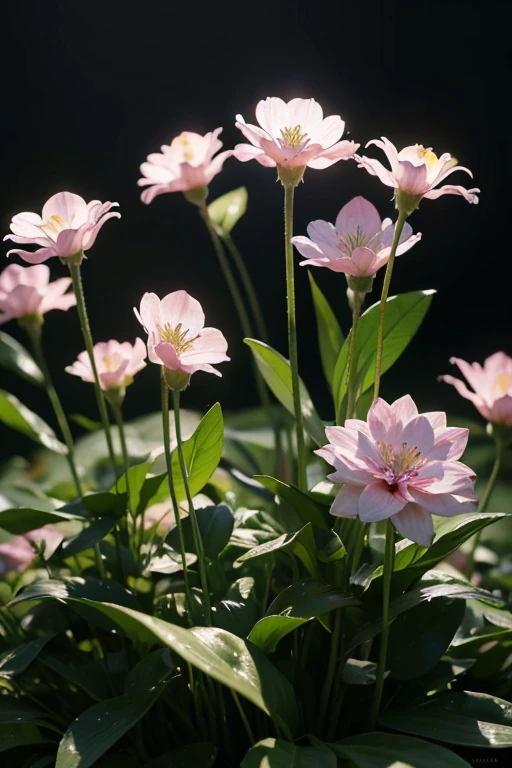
xmin=0 ymin=264 xmax=76 ymax=325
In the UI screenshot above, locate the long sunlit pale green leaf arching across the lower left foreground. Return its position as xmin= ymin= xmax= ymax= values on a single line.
xmin=58 ymin=600 xmax=297 ymax=731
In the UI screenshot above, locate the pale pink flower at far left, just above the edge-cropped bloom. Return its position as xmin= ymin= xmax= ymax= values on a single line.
xmin=4 ymin=192 xmax=121 ymax=264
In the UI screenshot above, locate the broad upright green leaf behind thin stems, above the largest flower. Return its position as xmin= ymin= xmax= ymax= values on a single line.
xmin=333 ymin=291 xmax=435 ymax=416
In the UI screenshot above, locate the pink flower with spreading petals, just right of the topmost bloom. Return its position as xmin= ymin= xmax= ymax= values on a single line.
xmin=356 ymin=136 xmax=480 ymax=203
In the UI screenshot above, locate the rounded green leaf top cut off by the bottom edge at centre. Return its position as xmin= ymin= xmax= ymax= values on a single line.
xmin=240 ymin=739 xmax=338 ymax=768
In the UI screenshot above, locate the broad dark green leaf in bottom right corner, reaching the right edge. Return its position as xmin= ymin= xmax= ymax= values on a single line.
xmin=379 ymin=691 xmax=512 ymax=747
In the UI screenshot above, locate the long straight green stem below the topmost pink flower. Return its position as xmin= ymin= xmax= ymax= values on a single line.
xmin=284 ymin=184 xmax=307 ymax=491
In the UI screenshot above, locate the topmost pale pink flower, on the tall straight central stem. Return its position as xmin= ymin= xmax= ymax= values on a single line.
xmin=233 ymin=97 xmax=359 ymax=169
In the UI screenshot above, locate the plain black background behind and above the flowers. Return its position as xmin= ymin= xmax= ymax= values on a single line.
xmin=0 ymin=0 xmax=512 ymax=460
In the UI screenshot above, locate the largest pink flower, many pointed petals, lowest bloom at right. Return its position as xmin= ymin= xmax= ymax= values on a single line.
xmin=316 ymin=395 xmax=476 ymax=547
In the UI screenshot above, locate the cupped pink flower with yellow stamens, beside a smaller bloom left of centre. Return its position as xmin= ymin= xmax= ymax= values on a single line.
xmin=134 ymin=291 xmax=230 ymax=376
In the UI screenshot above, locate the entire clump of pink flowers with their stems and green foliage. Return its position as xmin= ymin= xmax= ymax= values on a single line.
xmin=0 ymin=98 xmax=512 ymax=768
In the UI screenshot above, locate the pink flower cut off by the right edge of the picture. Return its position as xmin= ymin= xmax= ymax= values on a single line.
xmin=441 ymin=352 xmax=512 ymax=427
